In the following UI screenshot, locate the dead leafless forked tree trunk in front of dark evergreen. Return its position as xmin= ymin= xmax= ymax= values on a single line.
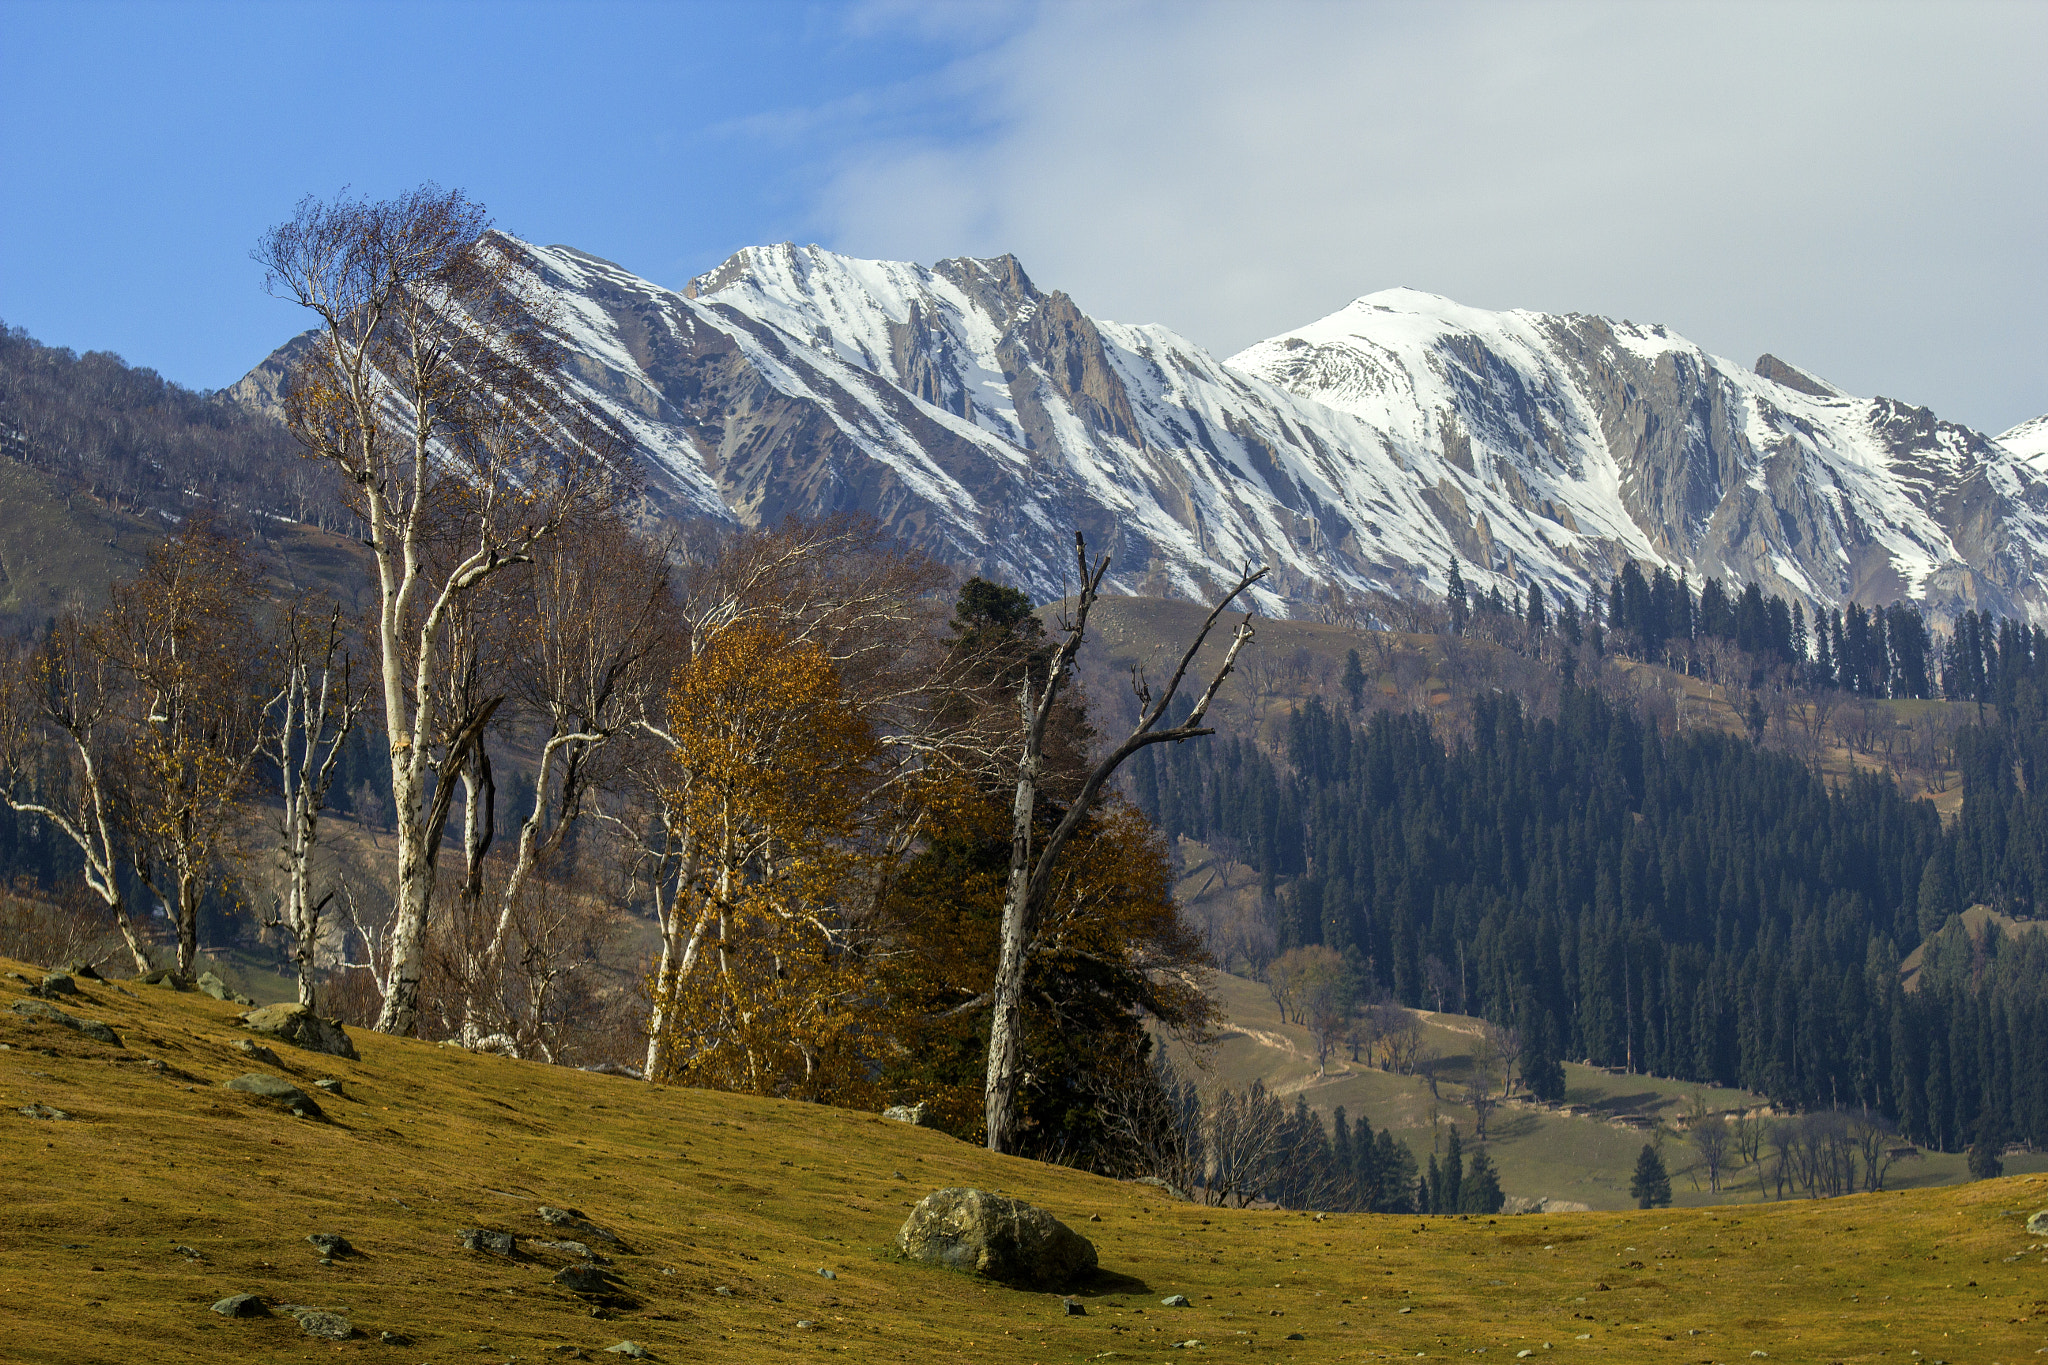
xmin=983 ymin=532 xmax=1266 ymax=1152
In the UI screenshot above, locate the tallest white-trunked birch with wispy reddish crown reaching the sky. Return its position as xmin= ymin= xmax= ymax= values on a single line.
xmin=256 ymin=186 xmax=616 ymax=1033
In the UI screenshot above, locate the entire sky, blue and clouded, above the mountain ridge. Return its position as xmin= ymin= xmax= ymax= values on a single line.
xmin=0 ymin=0 xmax=2048 ymax=432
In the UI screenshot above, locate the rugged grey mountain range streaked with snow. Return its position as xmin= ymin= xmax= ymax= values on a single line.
xmin=238 ymin=244 xmax=2048 ymax=620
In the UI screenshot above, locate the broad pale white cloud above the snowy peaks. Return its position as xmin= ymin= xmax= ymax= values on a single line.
xmin=819 ymin=0 xmax=2048 ymax=430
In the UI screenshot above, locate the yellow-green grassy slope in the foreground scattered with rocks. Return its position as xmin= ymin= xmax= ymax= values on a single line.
xmin=0 ymin=964 xmax=2048 ymax=1365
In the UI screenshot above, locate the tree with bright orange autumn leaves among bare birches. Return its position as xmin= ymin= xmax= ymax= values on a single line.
xmin=655 ymin=620 xmax=881 ymax=1103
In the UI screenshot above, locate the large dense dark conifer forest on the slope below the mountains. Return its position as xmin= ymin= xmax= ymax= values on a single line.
xmin=1133 ymin=683 xmax=2048 ymax=1150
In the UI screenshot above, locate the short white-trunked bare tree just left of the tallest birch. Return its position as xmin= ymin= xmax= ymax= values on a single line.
xmin=262 ymin=600 xmax=369 ymax=1007
